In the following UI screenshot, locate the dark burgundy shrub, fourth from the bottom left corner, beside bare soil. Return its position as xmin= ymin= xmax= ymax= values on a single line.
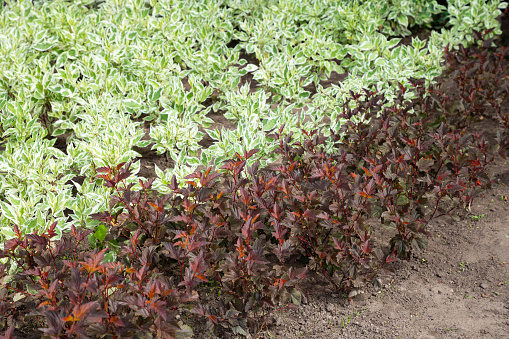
xmin=334 ymin=83 xmax=503 ymax=258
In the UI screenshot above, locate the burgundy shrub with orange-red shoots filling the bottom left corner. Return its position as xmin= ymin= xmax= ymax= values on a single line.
xmin=0 ymin=223 xmax=197 ymax=338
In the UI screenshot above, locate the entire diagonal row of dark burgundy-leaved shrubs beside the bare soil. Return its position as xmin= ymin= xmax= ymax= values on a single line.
xmin=0 ymin=32 xmax=509 ymax=338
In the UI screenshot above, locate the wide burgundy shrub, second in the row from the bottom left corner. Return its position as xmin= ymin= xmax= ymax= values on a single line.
xmin=90 ymin=159 xmax=306 ymax=335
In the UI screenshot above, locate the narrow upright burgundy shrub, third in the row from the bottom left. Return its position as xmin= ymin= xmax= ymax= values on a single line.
xmin=272 ymin=130 xmax=384 ymax=296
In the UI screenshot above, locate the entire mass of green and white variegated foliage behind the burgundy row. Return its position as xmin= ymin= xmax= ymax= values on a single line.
xmin=0 ymin=0 xmax=506 ymax=240
